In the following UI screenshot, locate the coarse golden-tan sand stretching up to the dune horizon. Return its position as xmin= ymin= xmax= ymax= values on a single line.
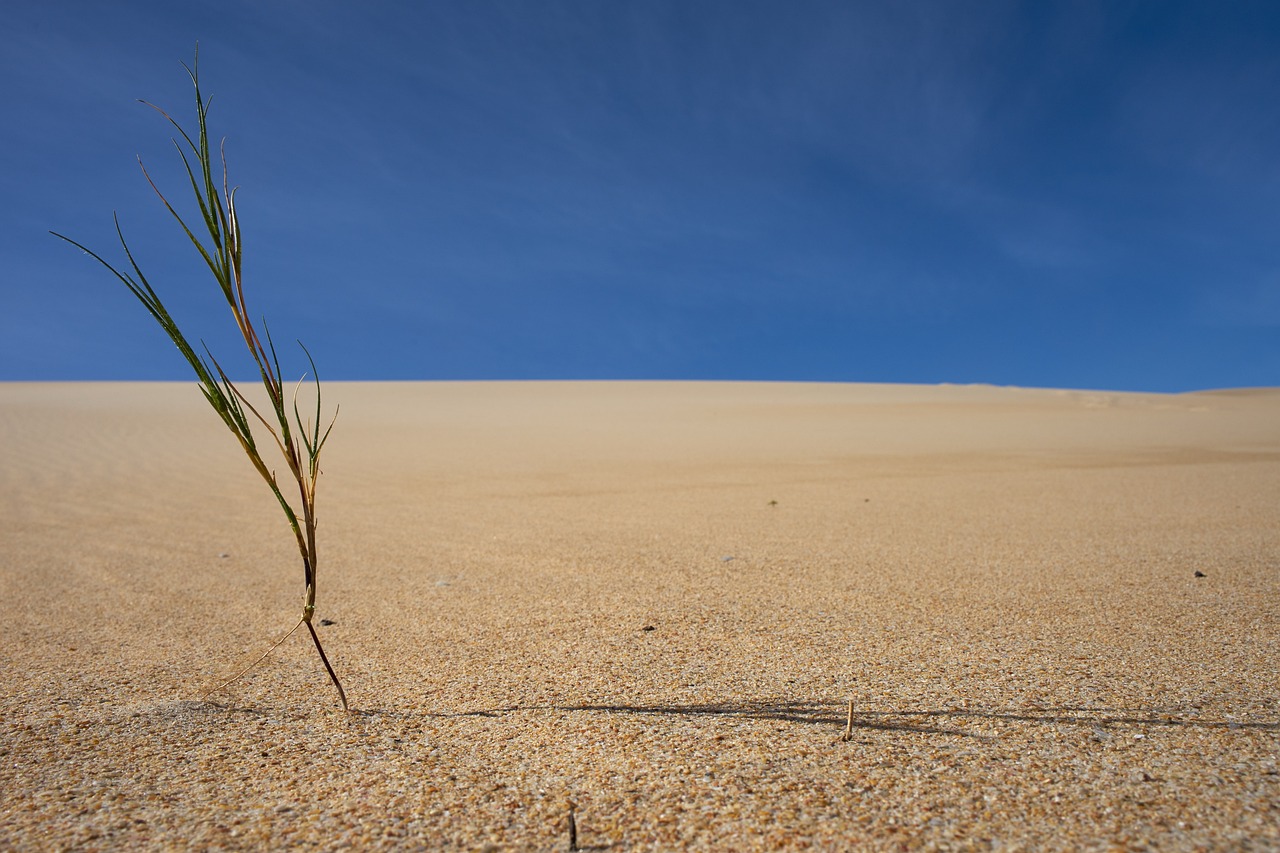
xmin=0 ymin=383 xmax=1280 ymax=850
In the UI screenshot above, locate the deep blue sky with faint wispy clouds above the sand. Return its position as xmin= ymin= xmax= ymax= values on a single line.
xmin=0 ymin=0 xmax=1280 ymax=391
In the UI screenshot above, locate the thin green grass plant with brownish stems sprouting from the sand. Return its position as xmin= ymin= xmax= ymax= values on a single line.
xmin=52 ymin=49 xmax=348 ymax=710
